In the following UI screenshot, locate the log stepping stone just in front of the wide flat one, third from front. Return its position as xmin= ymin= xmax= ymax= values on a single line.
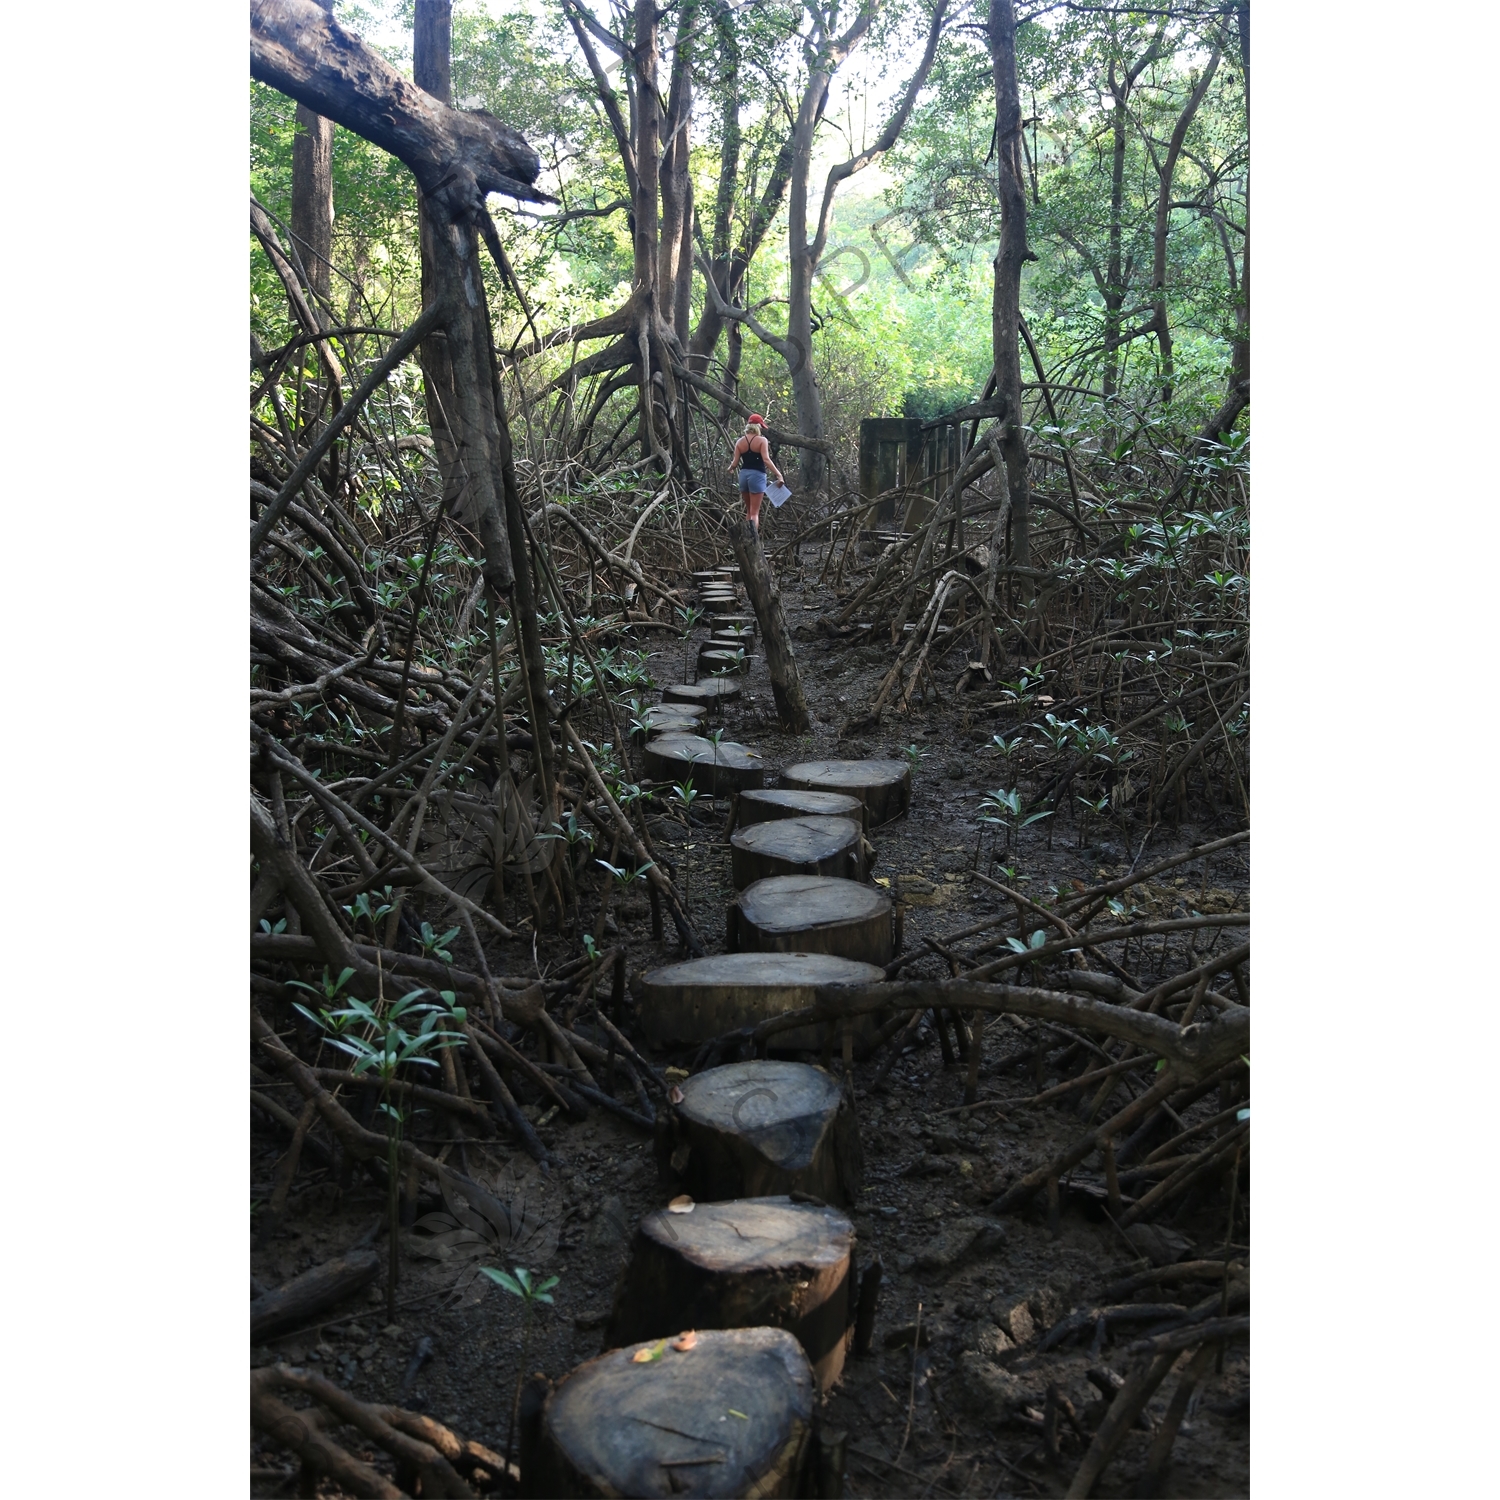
xmin=657 ymin=1058 xmax=864 ymax=1208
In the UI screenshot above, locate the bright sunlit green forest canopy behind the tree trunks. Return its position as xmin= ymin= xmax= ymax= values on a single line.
xmin=251 ymin=0 xmax=1248 ymax=464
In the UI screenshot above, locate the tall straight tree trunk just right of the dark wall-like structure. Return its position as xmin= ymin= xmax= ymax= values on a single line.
xmin=989 ymin=0 xmax=1035 ymax=567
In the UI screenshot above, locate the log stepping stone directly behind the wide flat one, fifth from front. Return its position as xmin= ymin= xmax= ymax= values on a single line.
xmin=728 ymin=875 xmax=896 ymax=968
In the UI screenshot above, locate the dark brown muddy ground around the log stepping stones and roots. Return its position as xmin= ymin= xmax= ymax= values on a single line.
xmin=251 ymin=545 xmax=1250 ymax=1497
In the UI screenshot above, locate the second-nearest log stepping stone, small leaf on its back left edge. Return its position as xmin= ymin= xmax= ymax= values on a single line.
xmin=605 ymin=1197 xmax=857 ymax=1391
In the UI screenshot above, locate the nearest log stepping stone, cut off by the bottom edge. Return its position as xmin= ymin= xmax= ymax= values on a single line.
xmin=527 ymin=1328 xmax=815 ymax=1497
